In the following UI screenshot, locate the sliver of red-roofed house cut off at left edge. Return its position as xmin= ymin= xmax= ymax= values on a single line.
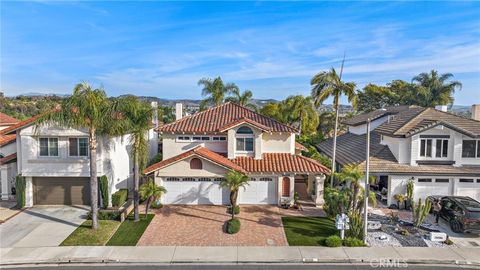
xmin=0 ymin=112 xmax=20 ymax=200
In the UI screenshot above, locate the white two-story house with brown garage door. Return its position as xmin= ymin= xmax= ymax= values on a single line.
xmin=0 ymin=104 xmax=157 ymax=206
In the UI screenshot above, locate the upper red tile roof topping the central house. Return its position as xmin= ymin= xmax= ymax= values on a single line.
xmin=157 ymin=102 xmax=298 ymax=133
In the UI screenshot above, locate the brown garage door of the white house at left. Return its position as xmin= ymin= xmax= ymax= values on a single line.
xmin=33 ymin=177 xmax=90 ymax=205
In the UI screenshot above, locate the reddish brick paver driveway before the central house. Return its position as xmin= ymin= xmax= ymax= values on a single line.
xmin=138 ymin=205 xmax=287 ymax=246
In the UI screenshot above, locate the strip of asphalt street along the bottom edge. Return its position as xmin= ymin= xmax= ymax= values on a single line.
xmin=6 ymin=264 xmax=480 ymax=270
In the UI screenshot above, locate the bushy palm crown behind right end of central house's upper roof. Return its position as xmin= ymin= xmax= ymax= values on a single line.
xmin=280 ymin=95 xmax=319 ymax=135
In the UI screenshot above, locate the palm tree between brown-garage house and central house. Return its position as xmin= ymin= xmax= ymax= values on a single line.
xmin=119 ymin=96 xmax=153 ymax=222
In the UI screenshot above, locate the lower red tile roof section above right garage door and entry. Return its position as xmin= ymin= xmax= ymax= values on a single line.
xmin=232 ymin=153 xmax=330 ymax=174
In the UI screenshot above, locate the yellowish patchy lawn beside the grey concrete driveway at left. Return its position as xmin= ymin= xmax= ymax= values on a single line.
xmin=60 ymin=220 xmax=120 ymax=246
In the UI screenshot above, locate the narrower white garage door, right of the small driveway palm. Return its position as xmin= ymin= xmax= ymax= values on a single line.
xmin=238 ymin=177 xmax=277 ymax=204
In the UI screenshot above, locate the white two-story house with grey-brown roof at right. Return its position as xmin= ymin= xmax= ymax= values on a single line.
xmin=318 ymin=105 xmax=480 ymax=205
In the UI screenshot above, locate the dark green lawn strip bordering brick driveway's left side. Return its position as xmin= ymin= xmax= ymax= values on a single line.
xmin=107 ymin=214 xmax=155 ymax=246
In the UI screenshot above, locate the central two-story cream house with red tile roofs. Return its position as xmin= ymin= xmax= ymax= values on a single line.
xmin=144 ymin=102 xmax=329 ymax=204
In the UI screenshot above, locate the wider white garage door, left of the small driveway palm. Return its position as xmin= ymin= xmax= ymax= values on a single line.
xmin=163 ymin=177 xmax=230 ymax=204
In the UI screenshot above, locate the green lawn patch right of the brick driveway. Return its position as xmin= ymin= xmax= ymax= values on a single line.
xmin=282 ymin=217 xmax=338 ymax=246
